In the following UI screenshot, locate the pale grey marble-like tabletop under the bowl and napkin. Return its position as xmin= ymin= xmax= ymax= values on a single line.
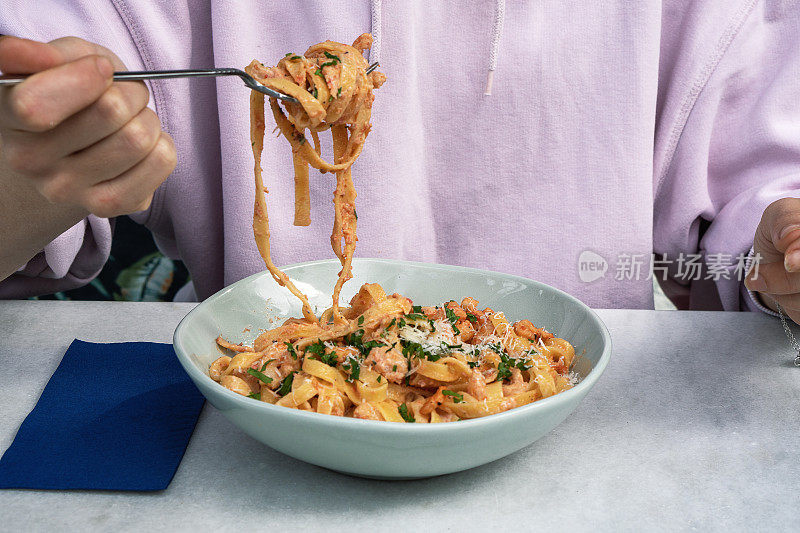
xmin=0 ymin=302 xmax=800 ymax=532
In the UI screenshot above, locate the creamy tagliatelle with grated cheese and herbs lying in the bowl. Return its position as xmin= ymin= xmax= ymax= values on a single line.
xmin=209 ymin=283 xmax=576 ymax=423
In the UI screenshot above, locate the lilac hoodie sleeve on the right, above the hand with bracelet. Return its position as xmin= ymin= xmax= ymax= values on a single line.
xmin=654 ymin=0 xmax=800 ymax=310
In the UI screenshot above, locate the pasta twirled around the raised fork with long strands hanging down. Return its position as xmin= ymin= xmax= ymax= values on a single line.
xmin=245 ymin=33 xmax=386 ymax=326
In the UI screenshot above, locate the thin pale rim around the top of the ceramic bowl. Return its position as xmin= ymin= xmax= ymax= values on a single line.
xmin=172 ymin=257 xmax=612 ymax=434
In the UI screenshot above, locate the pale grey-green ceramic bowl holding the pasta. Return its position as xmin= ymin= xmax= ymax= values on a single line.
xmin=174 ymin=259 xmax=611 ymax=479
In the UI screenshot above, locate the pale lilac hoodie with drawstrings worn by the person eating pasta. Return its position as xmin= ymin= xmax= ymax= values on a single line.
xmin=0 ymin=0 xmax=800 ymax=310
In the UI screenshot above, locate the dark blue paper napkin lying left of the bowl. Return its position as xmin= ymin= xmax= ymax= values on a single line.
xmin=0 ymin=340 xmax=204 ymax=491
